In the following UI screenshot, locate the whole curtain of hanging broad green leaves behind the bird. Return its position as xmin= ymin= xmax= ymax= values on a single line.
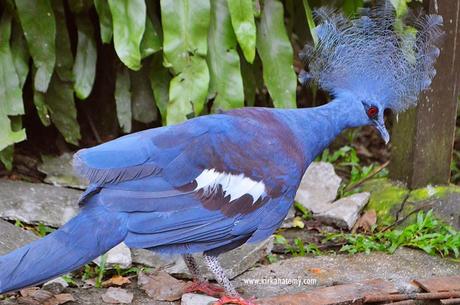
xmin=0 ymin=0 xmax=416 ymax=168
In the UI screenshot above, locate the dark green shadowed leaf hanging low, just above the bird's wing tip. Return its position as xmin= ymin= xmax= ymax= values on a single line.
xmin=45 ymin=73 xmax=81 ymax=145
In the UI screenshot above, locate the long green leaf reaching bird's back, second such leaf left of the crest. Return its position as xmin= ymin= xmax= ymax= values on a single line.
xmin=208 ymin=0 xmax=244 ymax=111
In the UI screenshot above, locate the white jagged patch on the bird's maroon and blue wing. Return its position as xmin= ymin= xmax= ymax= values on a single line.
xmin=195 ymin=168 xmax=266 ymax=204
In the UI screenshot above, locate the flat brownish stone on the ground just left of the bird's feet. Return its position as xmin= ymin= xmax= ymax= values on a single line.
xmin=138 ymin=271 xmax=186 ymax=301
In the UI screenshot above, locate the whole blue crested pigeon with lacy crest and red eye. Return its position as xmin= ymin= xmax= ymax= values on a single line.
xmin=0 ymin=7 xmax=442 ymax=305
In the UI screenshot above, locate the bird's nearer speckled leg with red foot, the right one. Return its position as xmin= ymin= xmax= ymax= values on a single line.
xmin=203 ymin=254 xmax=256 ymax=305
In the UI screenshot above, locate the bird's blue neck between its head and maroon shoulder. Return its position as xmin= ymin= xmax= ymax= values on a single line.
xmin=276 ymin=100 xmax=362 ymax=165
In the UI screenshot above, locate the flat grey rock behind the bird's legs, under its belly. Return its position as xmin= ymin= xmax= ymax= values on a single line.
xmin=133 ymin=237 xmax=273 ymax=279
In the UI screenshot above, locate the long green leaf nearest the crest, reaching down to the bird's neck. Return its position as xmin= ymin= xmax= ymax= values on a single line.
xmin=257 ymin=0 xmax=297 ymax=108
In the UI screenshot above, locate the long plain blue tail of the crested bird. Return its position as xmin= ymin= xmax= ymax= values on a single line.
xmin=0 ymin=206 xmax=127 ymax=294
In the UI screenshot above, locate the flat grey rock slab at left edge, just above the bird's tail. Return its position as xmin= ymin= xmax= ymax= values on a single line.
xmin=0 ymin=179 xmax=81 ymax=227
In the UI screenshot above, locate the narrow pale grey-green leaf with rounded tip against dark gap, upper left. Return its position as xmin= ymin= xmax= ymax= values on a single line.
xmin=73 ymin=15 xmax=97 ymax=100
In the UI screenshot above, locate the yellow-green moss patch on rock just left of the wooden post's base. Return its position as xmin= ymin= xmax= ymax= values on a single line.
xmin=362 ymin=178 xmax=409 ymax=225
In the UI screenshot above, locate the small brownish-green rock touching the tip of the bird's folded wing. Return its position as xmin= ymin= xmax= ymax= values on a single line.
xmin=38 ymin=153 xmax=88 ymax=189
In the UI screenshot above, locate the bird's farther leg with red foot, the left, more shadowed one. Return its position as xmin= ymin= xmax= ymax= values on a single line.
xmin=182 ymin=254 xmax=224 ymax=297
